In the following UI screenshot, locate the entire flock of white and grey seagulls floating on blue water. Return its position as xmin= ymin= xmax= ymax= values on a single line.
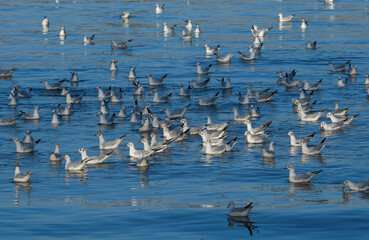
xmin=0 ymin=1 xmax=369 ymax=221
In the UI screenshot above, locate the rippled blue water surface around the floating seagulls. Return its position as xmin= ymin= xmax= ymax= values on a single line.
xmin=0 ymin=0 xmax=369 ymax=239
